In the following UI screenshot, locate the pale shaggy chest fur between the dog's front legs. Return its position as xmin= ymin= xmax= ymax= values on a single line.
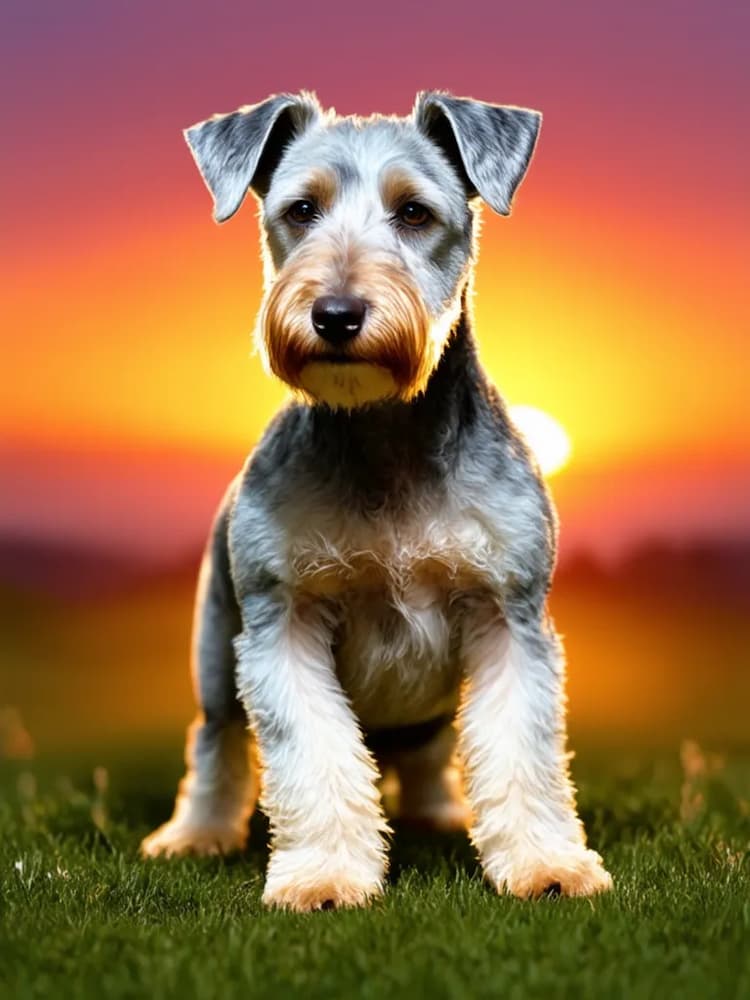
xmin=291 ymin=514 xmax=502 ymax=727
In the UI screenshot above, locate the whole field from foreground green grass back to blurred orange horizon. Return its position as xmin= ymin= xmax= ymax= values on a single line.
xmin=0 ymin=560 xmax=750 ymax=1000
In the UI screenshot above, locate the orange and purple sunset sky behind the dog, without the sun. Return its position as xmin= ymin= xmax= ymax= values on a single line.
xmin=0 ymin=0 xmax=750 ymax=559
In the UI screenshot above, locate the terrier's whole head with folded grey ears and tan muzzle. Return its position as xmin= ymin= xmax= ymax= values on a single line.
xmin=185 ymin=92 xmax=541 ymax=407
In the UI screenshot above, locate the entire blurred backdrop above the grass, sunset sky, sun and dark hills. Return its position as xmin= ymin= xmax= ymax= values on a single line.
xmin=0 ymin=0 xmax=750 ymax=760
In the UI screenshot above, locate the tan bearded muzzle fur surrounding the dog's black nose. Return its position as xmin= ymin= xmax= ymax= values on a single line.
xmin=259 ymin=248 xmax=442 ymax=408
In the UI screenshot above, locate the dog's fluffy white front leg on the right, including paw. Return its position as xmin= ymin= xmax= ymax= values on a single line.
xmin=459 ymin=602 xmax=612 ymax=898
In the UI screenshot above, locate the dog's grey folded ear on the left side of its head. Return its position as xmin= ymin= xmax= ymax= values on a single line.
xmin=184 ymin=91 xmax=322 ymax=222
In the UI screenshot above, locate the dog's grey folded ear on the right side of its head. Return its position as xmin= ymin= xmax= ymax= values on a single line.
xmin=413 ymin=90 xmax=542 ymax=215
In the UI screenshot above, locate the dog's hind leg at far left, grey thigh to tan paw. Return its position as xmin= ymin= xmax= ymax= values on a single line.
xmin=141 ymin=484 xmax=258 ymax=857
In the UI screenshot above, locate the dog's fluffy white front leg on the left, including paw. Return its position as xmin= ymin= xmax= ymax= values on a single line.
xmin=235 ymin=591 xmax=387 ymax=910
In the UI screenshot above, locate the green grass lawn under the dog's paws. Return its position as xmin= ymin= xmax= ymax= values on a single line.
xmin=0 ymin=747 xmax=750 ymax=1000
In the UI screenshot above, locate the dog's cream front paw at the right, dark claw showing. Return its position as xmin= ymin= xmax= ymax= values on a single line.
xmin=489 ymin=847 xmax=612 ymax=899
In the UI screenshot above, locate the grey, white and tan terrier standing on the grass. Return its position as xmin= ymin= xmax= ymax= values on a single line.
xmin=142 ymin=91 xmax=612 ymax=911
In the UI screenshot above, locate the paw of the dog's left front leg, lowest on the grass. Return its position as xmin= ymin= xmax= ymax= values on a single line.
xmin=263 ymin=851 xmax=384 ymax=913
